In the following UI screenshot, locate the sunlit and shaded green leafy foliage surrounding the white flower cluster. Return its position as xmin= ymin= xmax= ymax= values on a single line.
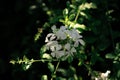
xmin=10 ymin=0 xmax=120 ymax=80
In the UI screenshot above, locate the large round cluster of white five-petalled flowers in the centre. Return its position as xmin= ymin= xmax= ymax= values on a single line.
xmin=45 ymin=25 xmax=84 ymax=58
